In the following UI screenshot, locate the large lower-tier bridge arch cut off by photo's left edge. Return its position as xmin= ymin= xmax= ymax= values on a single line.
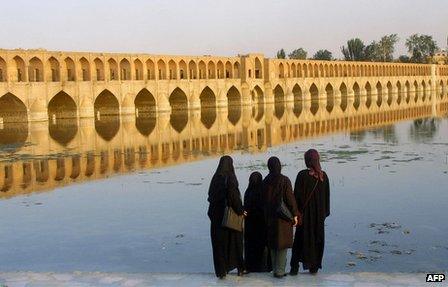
xmin=0 ymin=93 xmax=28 ymax=124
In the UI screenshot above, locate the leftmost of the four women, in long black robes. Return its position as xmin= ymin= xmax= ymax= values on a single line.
xmin=207 ymin=156 xmax=244 ymax=278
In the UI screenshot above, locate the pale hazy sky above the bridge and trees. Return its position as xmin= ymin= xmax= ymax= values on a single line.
xmin=0 ymin=0 xmax=448 ymax=57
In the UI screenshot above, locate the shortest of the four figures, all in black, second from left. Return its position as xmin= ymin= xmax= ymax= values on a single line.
xmin=244 ymin=171 xmax=272 ymax=272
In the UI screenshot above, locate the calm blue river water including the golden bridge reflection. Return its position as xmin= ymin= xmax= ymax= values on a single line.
xmin=0 ymin=102 xmax=448 ymax=272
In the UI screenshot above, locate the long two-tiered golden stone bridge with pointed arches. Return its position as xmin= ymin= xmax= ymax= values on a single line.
xmin=0 ymin=49 xmax=448 ymax=125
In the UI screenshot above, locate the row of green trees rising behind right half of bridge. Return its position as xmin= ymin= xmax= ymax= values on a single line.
xmin=277 ymin=34 xmax=439 ymax=63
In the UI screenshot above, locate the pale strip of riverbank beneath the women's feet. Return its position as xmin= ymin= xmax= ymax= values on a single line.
xmin=0 ymin=272 xmax=440 ymax=287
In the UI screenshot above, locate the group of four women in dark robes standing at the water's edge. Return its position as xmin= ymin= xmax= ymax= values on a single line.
xmin=208 ymin=149 xmax=330 ymax=278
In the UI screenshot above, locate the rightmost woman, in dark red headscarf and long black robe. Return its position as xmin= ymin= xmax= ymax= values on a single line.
xmin=290 ymin=149 xmax=330 ymax=275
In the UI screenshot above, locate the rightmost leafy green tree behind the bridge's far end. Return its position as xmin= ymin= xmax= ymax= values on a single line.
xmin=406 ymin=34 xmax=438 ymax=63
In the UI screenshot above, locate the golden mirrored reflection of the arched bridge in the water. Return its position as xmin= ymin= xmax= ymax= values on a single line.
xmin=0 ymin=93 xmax=448 ymax=198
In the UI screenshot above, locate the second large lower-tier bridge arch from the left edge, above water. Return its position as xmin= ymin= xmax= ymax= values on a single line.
xmin=48 ymin=91 xmax=77 ymax=121
